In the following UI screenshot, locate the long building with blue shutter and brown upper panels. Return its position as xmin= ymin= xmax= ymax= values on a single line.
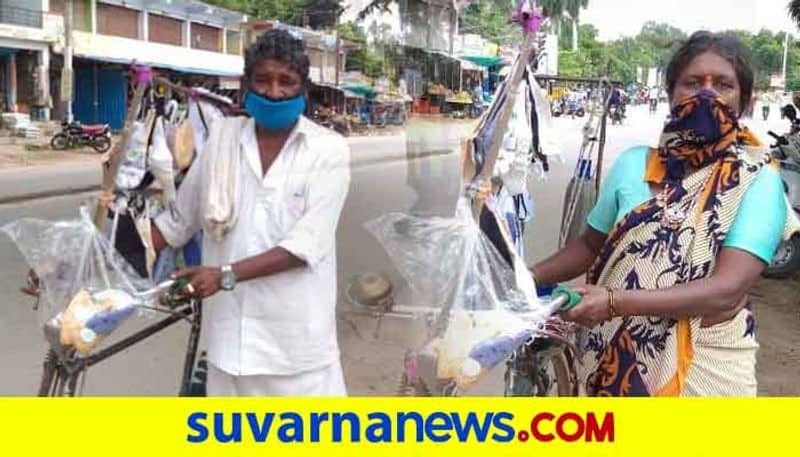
xmin=43 ymin=0 xmax=246 ymax=129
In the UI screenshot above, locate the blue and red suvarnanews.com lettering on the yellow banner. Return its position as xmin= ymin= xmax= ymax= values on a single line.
xmin=186 ymin=411 xmax=615 ymax=444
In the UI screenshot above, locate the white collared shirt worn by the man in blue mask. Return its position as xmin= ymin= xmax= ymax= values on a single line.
xmin=156 ymin=117 xmax=350 ymax=376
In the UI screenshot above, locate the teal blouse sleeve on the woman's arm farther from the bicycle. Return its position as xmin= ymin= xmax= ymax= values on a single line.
xmin=723 ymin=166 xmax=786 ymax=264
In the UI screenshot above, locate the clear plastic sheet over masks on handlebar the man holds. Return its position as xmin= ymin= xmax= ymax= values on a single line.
xmin=0 ymin=207 xmax=157 ymax=355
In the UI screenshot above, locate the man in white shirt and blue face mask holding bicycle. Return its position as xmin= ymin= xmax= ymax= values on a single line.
xmin=153 ymin=30 xmax=350 ymax=396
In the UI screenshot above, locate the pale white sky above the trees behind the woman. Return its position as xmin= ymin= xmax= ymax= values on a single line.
xmin=580 ymin=0 xmax=800 ymax=41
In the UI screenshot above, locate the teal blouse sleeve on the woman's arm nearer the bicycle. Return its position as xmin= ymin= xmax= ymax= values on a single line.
xmin=586 ymin=146 xmax=649 ymax=233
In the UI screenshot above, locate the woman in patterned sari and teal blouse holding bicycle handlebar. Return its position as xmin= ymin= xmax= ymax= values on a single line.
xmin=532 ymin=32 xmax=787 ymax=396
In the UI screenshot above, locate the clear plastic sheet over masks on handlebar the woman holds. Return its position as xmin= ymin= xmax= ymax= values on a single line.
xmin=366 ymin=198 xmax=549 ymax=389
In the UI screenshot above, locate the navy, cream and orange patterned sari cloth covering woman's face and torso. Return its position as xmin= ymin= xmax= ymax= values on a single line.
xmin=582 ymin=91 xmax=771 ymax=396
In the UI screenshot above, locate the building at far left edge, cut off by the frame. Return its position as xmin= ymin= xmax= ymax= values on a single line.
xmin=0 ymin=0 xmax=60 ymax=119
